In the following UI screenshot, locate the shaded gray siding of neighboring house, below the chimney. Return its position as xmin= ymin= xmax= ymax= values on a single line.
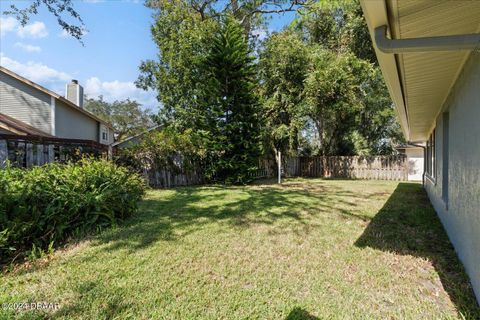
xmin=55 ymin=100 xmax=99 ymax=142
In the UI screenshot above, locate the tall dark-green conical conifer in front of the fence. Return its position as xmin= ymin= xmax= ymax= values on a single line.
xmin=203 ymin=19 xmax=260 ymax=184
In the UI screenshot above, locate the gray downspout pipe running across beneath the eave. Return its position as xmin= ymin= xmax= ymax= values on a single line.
xmin=375 ymin=25 xmax=480 ymax=53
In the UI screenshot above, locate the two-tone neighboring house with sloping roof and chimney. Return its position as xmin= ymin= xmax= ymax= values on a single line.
xmin=0 ymin=67 xmax=113 ymax=144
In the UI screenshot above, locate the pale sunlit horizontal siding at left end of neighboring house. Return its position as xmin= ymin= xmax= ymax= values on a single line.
xmin=0 ymin=72 xmax=52 ymax=134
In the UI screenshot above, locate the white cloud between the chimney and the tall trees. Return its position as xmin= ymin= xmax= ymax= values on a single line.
xmin=85 ymin=77 xmax=158 ymax=108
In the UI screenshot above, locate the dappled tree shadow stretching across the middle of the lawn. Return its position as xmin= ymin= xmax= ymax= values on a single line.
xmin=91 ymin=182 xmax=369 ymax=252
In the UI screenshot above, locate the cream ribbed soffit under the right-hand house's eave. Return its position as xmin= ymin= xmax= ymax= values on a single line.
xmin=362 ymin=0 xmax=480 ymax=141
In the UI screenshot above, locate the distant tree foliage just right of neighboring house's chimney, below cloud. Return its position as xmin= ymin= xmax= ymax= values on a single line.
xmin=85 ymin=96 xmax=153 ymax=140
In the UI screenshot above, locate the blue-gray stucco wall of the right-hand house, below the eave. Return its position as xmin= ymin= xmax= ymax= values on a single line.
xmin=425 ymin=52 xmax=480 ymax=303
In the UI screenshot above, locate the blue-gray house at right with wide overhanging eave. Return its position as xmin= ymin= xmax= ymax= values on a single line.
xmin=361 ymin=0 xmax=480 ymax=302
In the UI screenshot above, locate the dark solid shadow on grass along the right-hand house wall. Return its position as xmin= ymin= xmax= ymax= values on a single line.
xmin=355 ymin=183 xmax=480 ymax=319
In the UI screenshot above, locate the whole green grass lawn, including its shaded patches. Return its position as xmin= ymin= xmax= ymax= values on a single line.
xmin=0 ymin=179 xmax=480 ymax=320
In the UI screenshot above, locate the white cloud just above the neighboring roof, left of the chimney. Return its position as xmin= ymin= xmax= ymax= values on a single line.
xmin=0 ymin=53 xmax=72 ymax=85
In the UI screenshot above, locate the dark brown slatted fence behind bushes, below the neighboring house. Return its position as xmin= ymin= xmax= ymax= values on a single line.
xmin=0 ymin=134 xmax=108 ymax=168
